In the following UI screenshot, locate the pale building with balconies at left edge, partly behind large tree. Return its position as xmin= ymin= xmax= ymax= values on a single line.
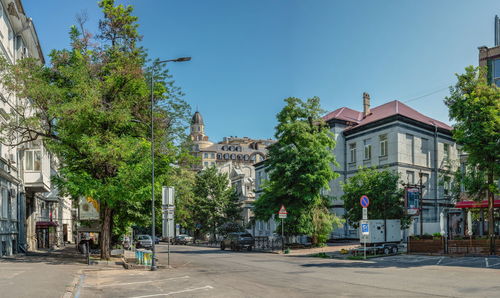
xmin=0 ymin=0 xmax=72 ymax=256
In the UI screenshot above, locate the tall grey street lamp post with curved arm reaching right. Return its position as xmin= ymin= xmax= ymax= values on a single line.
xmin=151 ymin=57 xmax=191 ymax=271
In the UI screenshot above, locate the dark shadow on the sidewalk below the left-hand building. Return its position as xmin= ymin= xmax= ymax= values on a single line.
xmin=0 ymin=244 xmax=87 ymax=265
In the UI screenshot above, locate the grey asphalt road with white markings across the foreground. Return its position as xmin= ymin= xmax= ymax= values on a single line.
xmin=75 ymin=245 xmax=500 ymax=298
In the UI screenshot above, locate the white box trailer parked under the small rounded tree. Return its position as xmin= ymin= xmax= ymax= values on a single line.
xmin=358 ymin=219 xmax=401 ymax=244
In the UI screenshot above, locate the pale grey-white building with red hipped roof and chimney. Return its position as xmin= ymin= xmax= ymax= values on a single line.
xmin=323 ymin=93 xmax=459 ymax=238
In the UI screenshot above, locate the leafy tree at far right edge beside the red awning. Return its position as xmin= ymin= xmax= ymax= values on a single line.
xmin=444 ymin=66 xmax=500 ymax=252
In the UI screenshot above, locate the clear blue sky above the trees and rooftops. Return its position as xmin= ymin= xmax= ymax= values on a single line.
xmin=23 ymin=0 xmax=500 ymax=141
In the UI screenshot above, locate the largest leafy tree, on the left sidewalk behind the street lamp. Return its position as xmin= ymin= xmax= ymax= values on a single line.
xmin=0 ymin=0 xmax=189 ymax=259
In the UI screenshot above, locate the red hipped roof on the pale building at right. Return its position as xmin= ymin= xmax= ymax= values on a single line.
xmin=323 ymin=100 xmax=452 ymax=130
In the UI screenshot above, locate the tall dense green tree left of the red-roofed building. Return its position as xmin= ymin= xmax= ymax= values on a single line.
xmin=254 ymin=97 xmax=340 ymax=244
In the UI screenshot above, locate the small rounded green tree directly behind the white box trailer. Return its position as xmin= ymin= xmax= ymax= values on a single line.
xmin=342 ymin=168 xmax=409 ymax=227
